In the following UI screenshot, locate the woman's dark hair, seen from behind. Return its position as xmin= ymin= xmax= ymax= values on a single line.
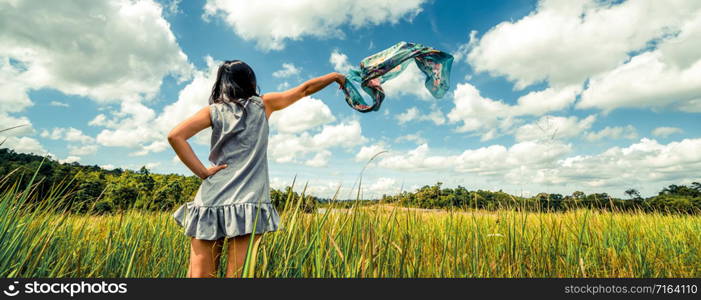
xmin=209 ymin=60 xmax=260 ymax=104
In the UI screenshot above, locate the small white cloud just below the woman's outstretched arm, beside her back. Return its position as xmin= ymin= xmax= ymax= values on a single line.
xmin=269 ymin=97 xmax=336 ymax=133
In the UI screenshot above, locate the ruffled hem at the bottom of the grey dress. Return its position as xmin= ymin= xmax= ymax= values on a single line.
xmin=173 ymin=202 xmax=282 ymax=240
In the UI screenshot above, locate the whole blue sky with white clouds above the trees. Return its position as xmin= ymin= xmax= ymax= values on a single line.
xmin=0 ymin=0 xmax=701 ymax=198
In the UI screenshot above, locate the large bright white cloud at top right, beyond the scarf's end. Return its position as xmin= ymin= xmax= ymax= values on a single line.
xmin=467 ymin=0 xmax=701 ymax=89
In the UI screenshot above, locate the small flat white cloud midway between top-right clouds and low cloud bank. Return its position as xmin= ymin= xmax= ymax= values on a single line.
xmin=515 ymin=115 xmax=596 ymax=141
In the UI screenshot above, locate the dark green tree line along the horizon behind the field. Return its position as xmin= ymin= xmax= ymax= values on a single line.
xmin=0 ymin=149 xmax=701 ymax=214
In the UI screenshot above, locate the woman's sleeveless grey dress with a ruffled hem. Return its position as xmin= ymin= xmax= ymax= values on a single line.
xmin=173 ymin=96 xmax=280 ymax=240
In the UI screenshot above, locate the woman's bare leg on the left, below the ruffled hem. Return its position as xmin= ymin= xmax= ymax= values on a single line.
xmin=187 ymin=238 xmax=224 ymax=278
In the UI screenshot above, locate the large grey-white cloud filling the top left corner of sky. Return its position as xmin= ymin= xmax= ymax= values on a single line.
xmin=0 ymin=0 xmax=191 ymax=103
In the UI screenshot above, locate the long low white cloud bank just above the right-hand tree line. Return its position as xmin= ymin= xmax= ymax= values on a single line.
xmin=377 ymin=138 xmax=701 ymax=190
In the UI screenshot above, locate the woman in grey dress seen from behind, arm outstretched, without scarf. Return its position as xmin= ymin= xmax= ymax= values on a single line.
xmin=168 ymin=60 xmax=345 ymax=277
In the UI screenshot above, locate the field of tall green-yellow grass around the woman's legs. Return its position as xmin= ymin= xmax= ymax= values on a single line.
xmin=0 ymin=176 xmax=701 ymax=277
